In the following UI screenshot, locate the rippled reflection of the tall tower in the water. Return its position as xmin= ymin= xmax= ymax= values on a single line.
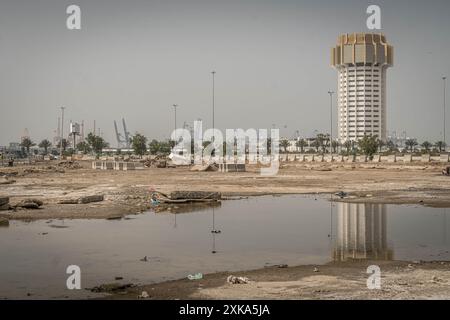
xmin=333 ymin=202 xmax=393 ymax=261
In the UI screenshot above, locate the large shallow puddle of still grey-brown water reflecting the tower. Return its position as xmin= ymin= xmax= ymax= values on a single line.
xmin=0 ymin=196 xmax=450 ymax=298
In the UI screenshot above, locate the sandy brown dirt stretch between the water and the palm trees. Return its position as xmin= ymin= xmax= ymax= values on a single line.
xmin=0 ymin=162 xmax=450 ymax=219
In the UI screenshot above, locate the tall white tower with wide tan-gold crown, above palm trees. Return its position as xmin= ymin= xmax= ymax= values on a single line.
xmin=331 ymin=33 xmax=393 ymax=143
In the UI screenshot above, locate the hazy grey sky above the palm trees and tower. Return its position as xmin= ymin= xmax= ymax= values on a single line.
xmin=0 ymin=0 xmax=450 ymax=146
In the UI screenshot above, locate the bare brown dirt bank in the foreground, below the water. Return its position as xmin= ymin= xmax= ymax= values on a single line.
xmin=104 ymin=261 xmax=450 ymax=300
